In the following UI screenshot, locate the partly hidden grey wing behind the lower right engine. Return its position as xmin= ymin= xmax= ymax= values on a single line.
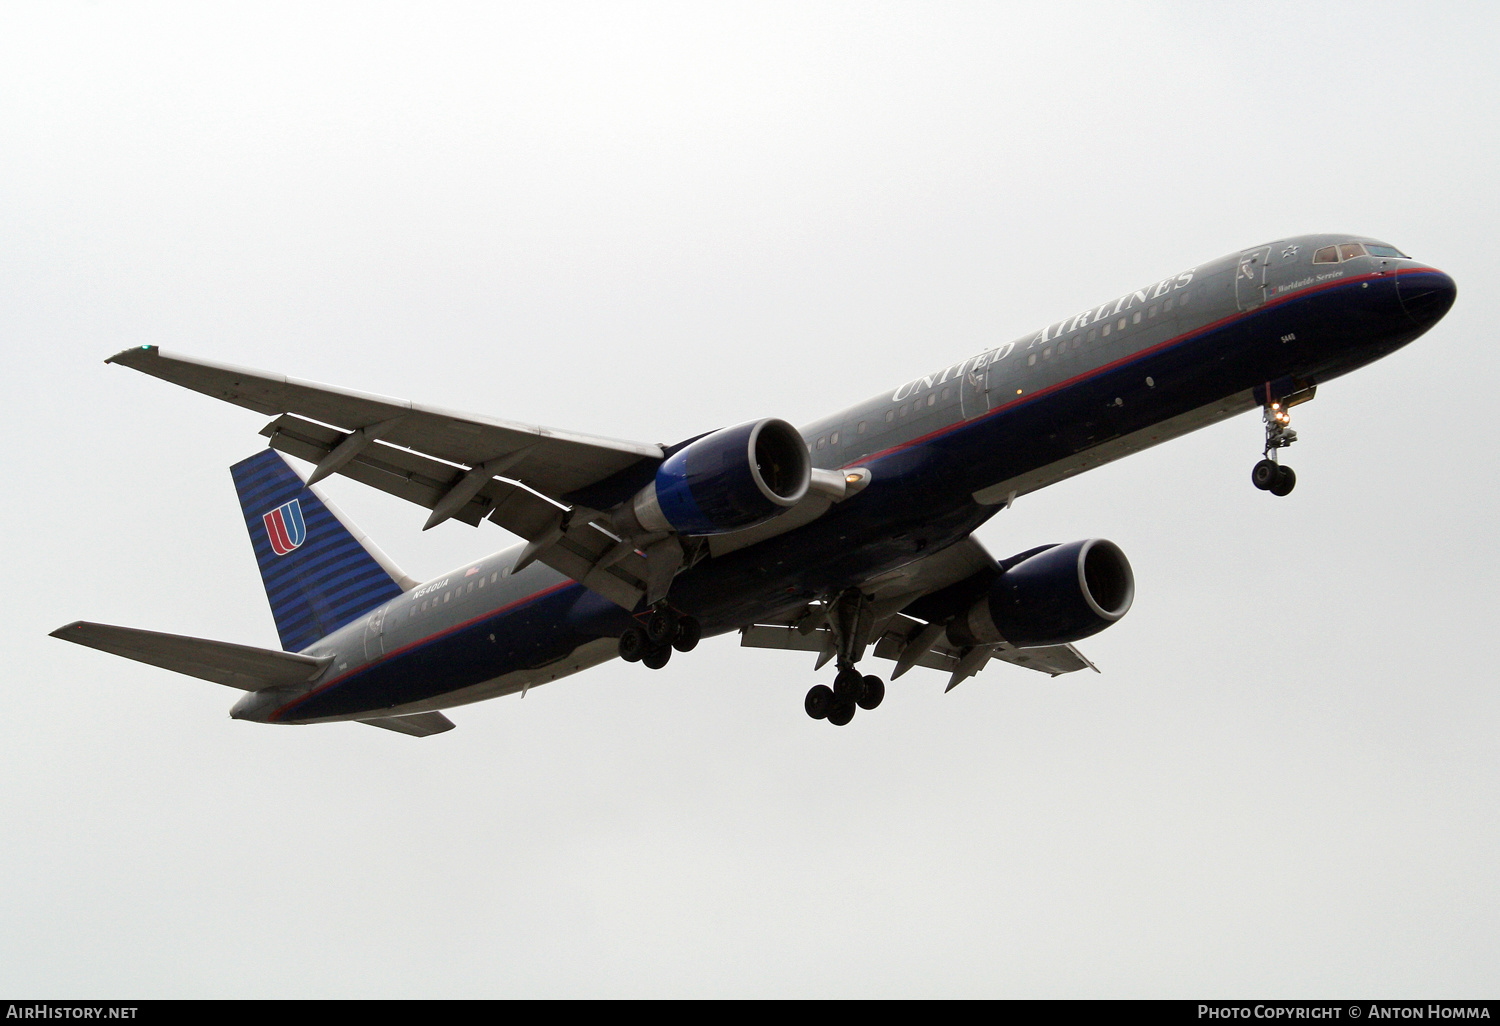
xmin=740 ymin=537 xmax=1098 ymax=692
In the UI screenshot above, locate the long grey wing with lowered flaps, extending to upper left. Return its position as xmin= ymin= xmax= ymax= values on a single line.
xmin=107 ymin=345 xmax=669 ymax=609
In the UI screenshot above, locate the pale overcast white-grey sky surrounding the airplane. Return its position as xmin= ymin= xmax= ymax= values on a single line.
xmin=0 ymin=2 xmax=1500 ymax=998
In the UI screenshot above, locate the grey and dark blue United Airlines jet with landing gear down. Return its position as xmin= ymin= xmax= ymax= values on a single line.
xmin=53 ymin=234 xmax=1457 ymax=737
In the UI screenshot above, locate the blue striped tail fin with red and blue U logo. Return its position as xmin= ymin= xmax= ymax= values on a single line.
xmin=230 ymin=449 xmax=416 ymax=653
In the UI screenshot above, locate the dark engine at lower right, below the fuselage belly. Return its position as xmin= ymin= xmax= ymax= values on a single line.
xmin=948 ymin=539 xmax=1136 ymax=648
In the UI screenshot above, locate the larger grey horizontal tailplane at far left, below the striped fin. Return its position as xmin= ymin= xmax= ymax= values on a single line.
xmin=53 ymin=620 xmax=333 ymax=692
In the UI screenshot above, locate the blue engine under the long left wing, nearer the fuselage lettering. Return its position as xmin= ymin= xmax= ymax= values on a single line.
xmin=630 ymin=419 xmax=813 ymax=534
